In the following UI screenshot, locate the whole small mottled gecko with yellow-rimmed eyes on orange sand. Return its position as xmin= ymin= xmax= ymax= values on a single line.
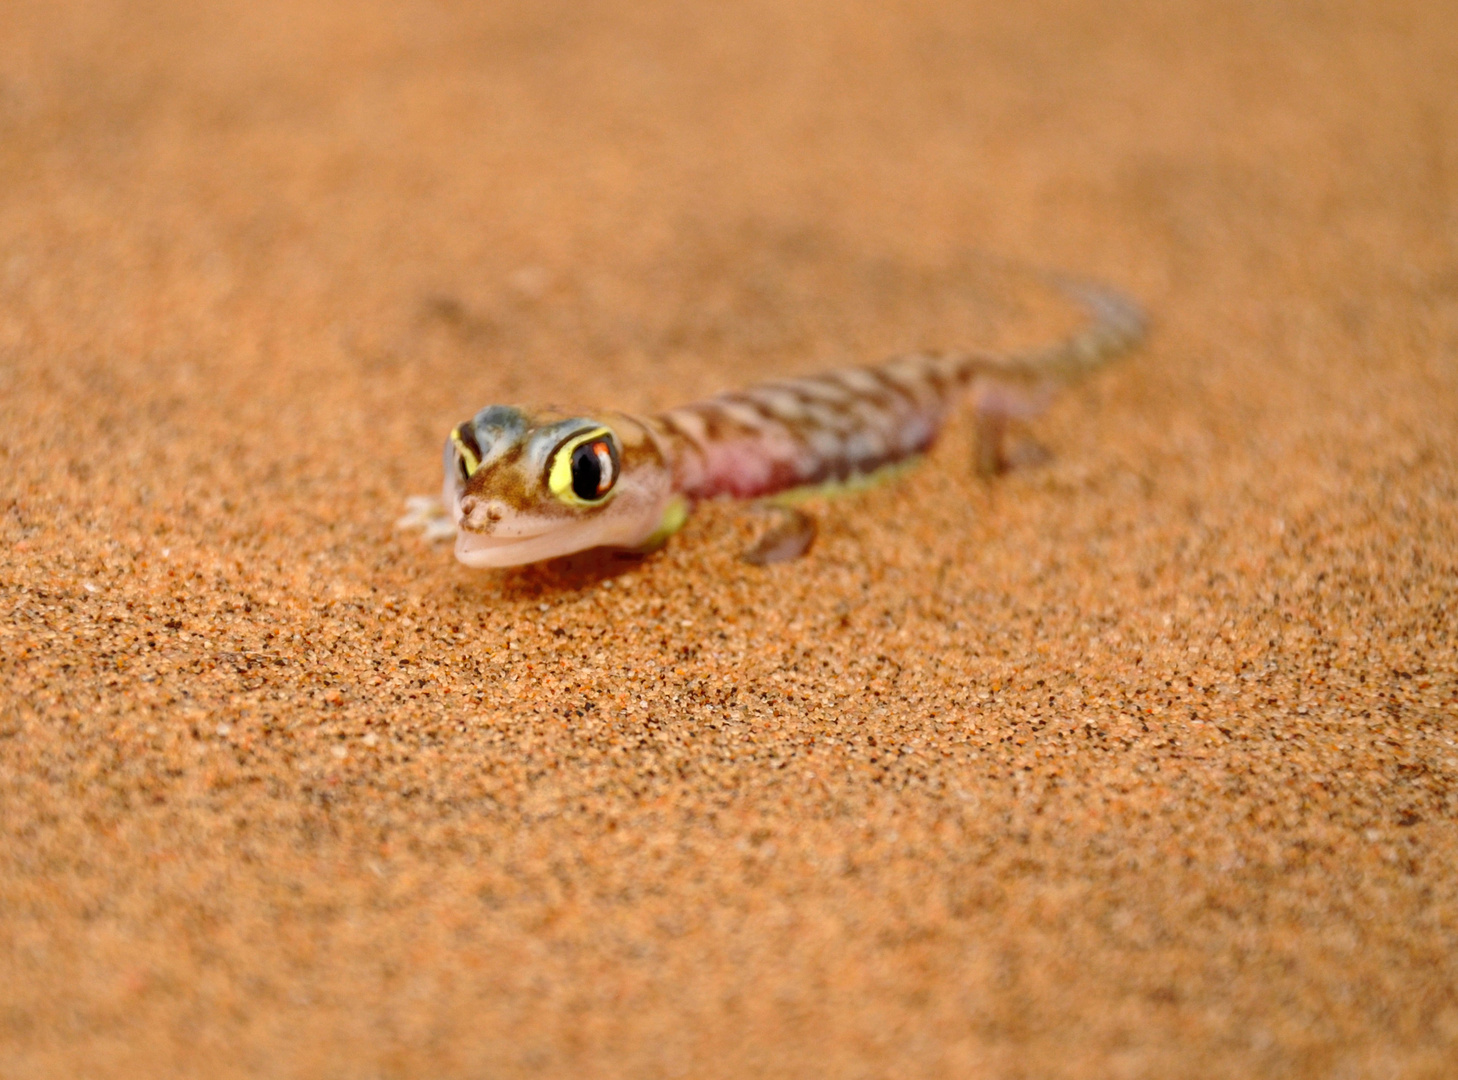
xmin=399 ymin=281 xmax=1145 ymax=567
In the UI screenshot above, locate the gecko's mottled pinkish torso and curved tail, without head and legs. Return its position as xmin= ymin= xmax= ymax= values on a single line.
xmin=649 ymin=280 xmax=1145 ymax=500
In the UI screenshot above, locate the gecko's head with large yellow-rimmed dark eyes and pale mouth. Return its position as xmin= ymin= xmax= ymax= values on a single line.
xmin=443 ymin=405 xmax=666 ymax=567
